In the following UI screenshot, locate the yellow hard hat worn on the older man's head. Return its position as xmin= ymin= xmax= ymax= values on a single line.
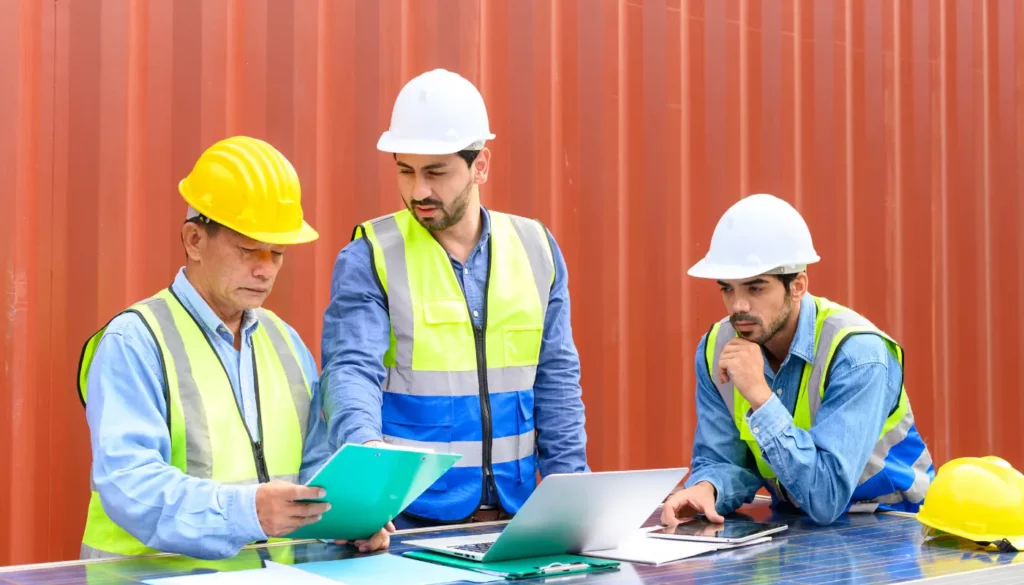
xmin=178 ymin=136 xmax=319 ymax=244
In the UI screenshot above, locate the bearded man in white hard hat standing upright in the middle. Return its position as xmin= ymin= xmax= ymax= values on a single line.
xmin=323 ymin=70 xmax=589 ymax=528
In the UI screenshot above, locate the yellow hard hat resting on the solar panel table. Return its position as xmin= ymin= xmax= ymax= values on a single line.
xmin=918 ymin=456 xmax=1024 ymax=551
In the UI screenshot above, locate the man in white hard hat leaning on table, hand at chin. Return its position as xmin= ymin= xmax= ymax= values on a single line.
xmin=662 ymin=195 xmax=935 ymax=525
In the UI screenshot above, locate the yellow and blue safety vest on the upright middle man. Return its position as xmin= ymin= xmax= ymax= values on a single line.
xmin=353 ymin=210 xmax=555 ymax=521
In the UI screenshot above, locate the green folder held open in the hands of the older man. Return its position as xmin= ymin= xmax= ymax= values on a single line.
xmin=287 ymin=445 xmax=462 ymax=540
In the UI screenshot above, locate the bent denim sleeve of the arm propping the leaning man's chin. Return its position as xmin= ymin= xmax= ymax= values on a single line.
xmin=748 ymin=335 xmax=902 ymax=524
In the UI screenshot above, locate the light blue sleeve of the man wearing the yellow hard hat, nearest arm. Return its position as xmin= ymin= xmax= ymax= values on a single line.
xmin=86 ymin=314 xmax=266 ymax=558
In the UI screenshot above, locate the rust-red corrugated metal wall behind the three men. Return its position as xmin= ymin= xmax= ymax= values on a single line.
xmin=0 ymin=0 xmax=1024 ymax=563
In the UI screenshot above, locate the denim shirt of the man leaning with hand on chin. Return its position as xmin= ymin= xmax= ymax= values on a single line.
xmin=685 ymin=294 xmax=903 ymax=524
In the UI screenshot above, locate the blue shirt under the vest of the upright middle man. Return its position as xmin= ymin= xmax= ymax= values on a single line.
xmin=321 ymin=208 xmax=589 ymax=504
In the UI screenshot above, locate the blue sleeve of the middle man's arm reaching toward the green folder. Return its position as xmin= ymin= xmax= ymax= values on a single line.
xmin=321 ymin=239 xmax=391 ymax=449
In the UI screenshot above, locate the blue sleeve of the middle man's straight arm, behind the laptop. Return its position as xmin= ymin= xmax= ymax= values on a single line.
xmin=534 ymin=228 xmax=590 ymax=477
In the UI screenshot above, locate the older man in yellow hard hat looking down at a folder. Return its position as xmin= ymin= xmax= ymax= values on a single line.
xmin=79 ymin=136 xmax=388 ymax=559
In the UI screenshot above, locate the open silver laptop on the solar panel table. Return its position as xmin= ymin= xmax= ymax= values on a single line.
xmin=404 ymin=467 xmax=689 ymax=562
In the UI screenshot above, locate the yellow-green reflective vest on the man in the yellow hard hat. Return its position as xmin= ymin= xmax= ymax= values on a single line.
xmin=78 ymin=289 xmax=311 ymax=558
